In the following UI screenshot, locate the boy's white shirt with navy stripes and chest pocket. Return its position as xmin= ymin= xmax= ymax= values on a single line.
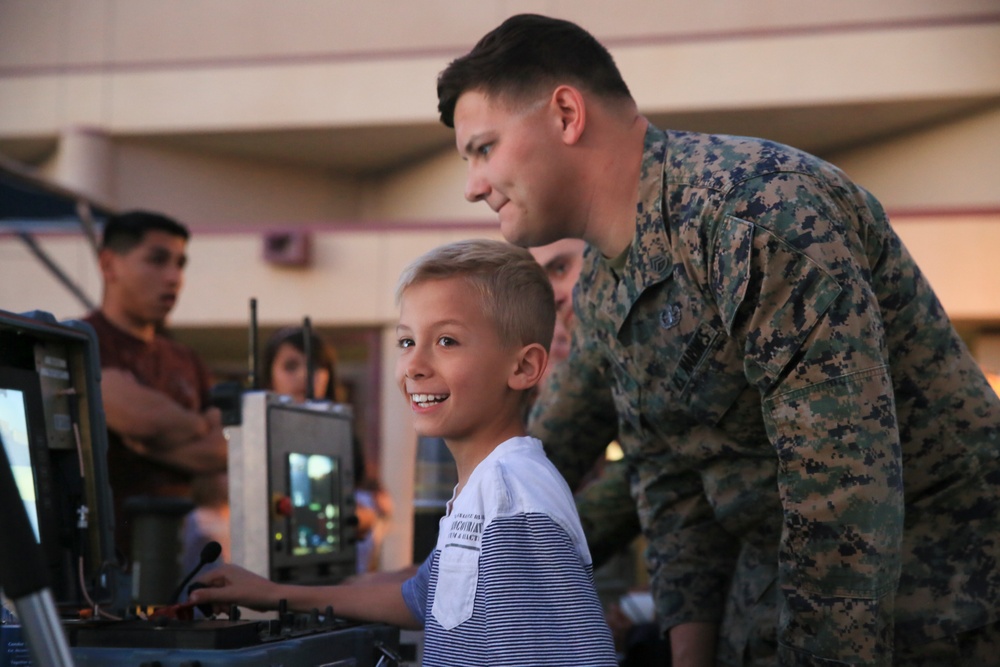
xmin=403 ymin=438 xmax=617 ymax=667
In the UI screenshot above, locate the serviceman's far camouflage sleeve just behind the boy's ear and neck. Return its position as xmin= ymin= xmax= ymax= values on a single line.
xmin=528 ymin=326 xmax=618 ymax=490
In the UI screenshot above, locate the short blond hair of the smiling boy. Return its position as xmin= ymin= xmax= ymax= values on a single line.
xmin=396 ymin=239 xmax=556 ymax=351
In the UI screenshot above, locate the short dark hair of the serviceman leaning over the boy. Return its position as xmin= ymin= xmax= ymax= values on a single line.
xmin=438 ymin=14 xmax=632 ymax=127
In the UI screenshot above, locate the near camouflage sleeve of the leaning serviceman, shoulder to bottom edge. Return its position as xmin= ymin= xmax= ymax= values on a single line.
xmin=712 ymin=173 xmax=903 ymax=665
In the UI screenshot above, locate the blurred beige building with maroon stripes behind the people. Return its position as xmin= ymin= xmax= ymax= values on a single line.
xmin=0 ymin=0 xmax=1000 ymax=568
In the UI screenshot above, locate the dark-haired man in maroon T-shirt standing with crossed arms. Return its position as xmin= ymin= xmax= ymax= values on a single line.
xmin=84 ymin=211 xmax=226 ymax=559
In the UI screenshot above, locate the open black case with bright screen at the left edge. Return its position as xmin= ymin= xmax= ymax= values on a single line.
xmin=0 ymin=311 xmax=119 ymax=614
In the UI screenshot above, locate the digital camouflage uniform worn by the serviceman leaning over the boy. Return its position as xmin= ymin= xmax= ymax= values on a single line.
xmin=530 ymin=127 xmax=1000 ymax=665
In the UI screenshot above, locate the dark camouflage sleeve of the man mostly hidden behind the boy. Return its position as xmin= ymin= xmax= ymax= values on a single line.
xmin=575 ymin=460 xmax=640 ymax=568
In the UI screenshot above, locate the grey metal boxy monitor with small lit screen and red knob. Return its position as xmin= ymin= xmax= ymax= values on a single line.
xmin=227 ymin=391 xmax=357 ymax=584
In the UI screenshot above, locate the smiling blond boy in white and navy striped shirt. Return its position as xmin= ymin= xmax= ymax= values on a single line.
xmin=191 ymin=240 xmax=617 ymax=667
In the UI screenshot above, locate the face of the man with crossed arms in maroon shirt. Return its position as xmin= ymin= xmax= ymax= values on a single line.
xmin=102 ymin=230 xmax=187 ymax=325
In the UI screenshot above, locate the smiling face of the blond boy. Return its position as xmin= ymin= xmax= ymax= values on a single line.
xmin=396 ymin=278 xmax=521 ymax=446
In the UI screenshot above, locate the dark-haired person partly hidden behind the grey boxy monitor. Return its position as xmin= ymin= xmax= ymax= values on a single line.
xmin=261 ymin=327 xmax=392 ymax=573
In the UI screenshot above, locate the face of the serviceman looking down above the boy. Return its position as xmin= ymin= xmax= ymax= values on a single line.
xmin=455 ymin=91 xmax=574 ymax=247
